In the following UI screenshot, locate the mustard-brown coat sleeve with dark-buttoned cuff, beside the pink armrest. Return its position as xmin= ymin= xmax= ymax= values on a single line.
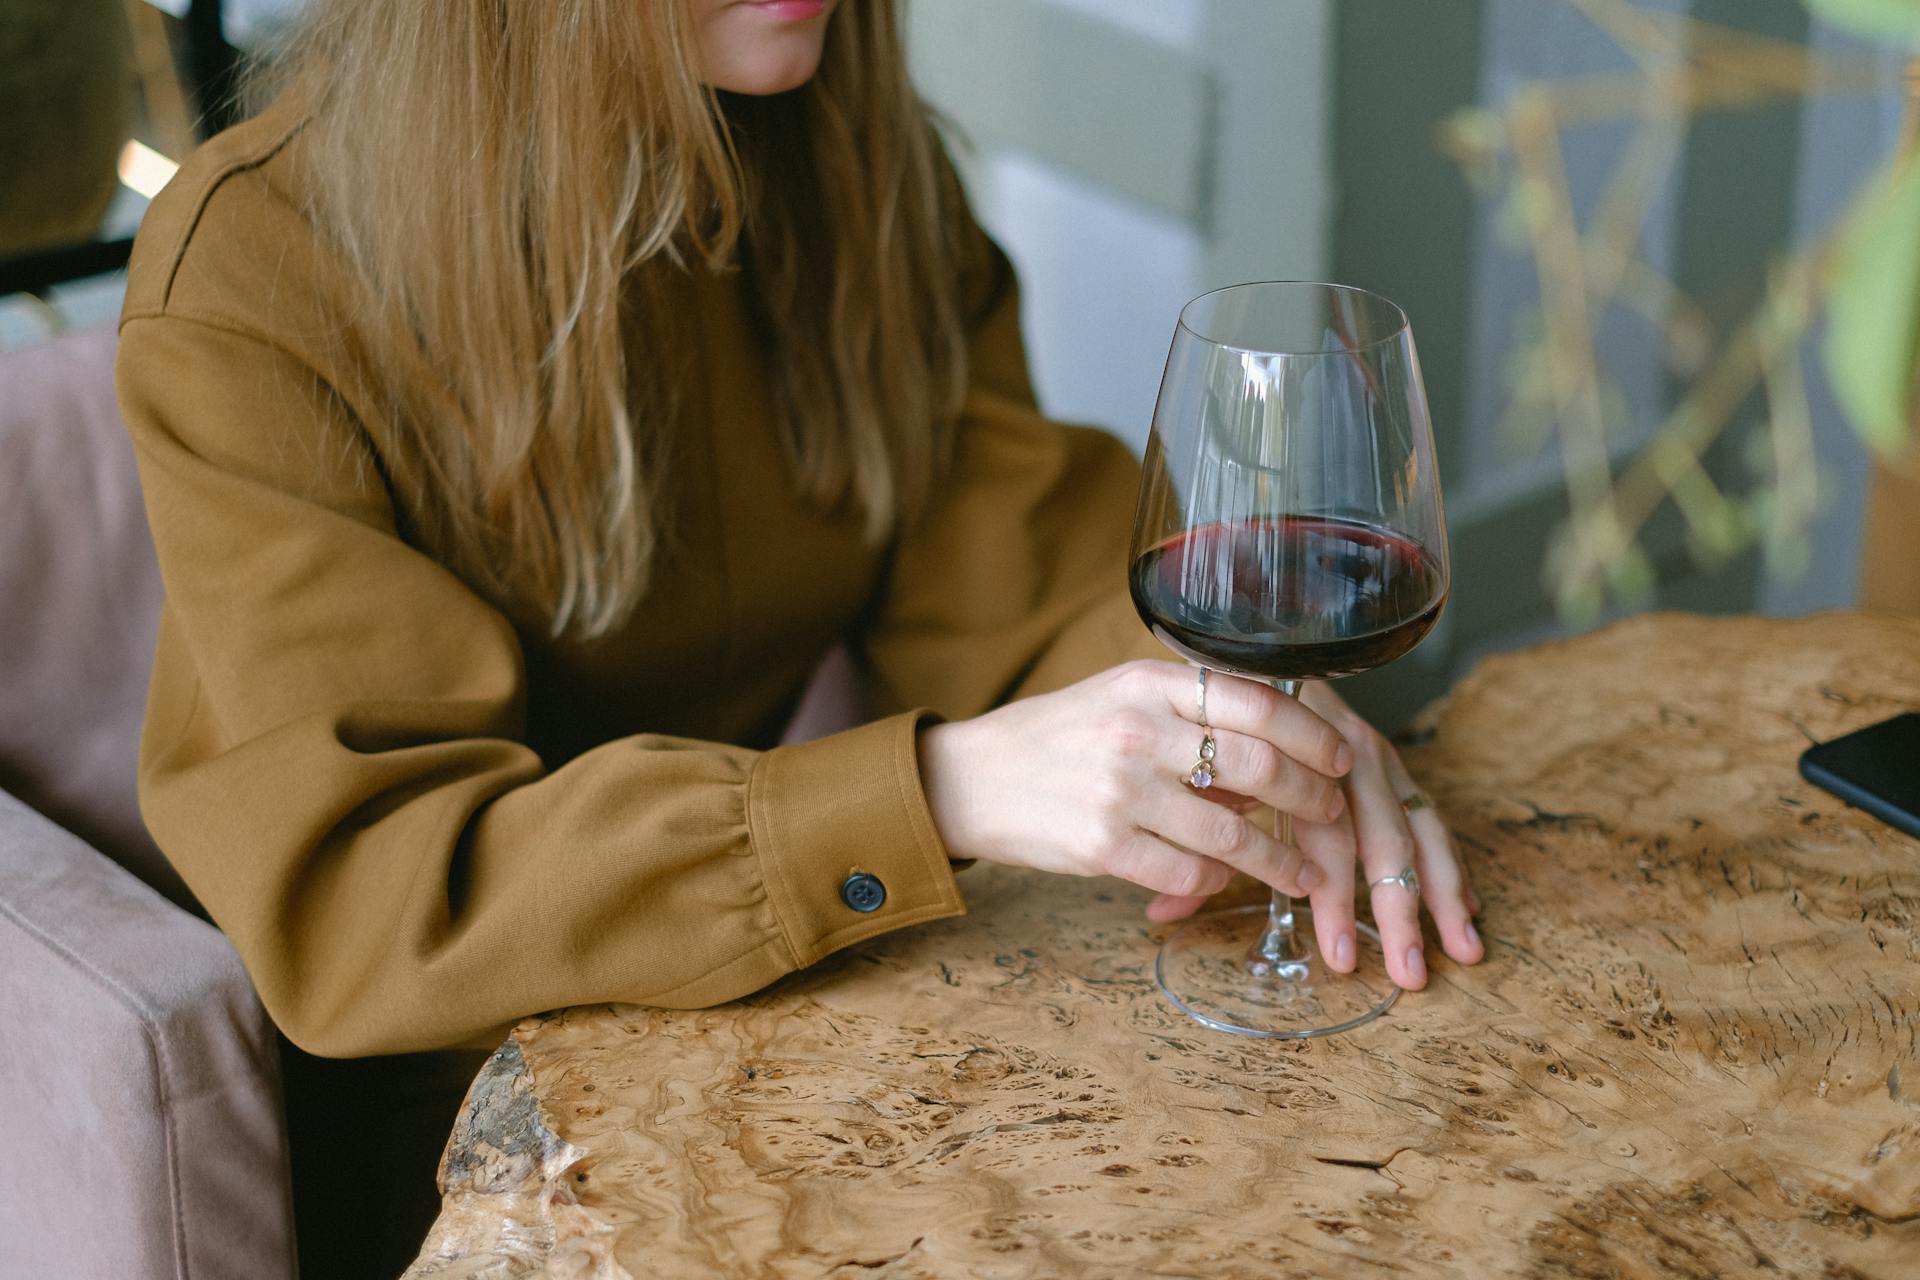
xmin=119 ymin=313 xmax=962 ymax=1055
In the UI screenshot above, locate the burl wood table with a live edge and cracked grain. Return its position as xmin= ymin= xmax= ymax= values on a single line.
xmin=409 ymin=614 xmax=1920 ymax=1280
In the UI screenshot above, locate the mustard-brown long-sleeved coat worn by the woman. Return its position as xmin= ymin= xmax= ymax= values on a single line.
xmin=119 ymin=109 xmax=1156 ymax=1055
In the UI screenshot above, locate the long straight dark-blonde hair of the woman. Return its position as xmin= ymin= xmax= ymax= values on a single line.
xmin=263 ymin=0 xmax=966 ymax=637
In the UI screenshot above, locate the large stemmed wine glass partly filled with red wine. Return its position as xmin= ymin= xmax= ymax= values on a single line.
xmin=1129 ymin=280 xmax=1448 ymax=1040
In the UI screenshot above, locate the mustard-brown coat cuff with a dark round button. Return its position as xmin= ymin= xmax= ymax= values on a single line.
xmin=747 ymin=712 xmax=966 ymax=967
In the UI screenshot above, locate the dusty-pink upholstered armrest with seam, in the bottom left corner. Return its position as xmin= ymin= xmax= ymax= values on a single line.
xmin=0 ymin=791 xmax=294 ymax=1280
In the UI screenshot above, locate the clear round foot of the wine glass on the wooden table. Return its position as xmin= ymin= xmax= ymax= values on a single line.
xmin=1154 ymin=902 xmax=1400 ymax=1040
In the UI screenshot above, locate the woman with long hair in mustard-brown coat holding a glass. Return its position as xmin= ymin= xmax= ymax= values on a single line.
xmin=121 ymin=0 xmax=1480 ymax=1258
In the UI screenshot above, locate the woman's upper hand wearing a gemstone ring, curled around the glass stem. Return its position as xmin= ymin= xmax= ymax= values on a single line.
xmin=920 ymin=662 xmax=1359 ymax=924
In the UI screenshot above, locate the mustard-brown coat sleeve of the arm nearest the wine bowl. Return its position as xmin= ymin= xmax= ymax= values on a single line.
xmin=858 ymin=236 xmax=1169 ymax=718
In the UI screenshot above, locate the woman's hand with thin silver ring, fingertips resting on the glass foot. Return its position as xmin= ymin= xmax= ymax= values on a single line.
xmin=1146 ymin=683 xmax=1486 ymax=990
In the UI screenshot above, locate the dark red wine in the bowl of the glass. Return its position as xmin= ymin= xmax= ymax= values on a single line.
xmin=1129 ymin=516 xmax=1446 ymax=679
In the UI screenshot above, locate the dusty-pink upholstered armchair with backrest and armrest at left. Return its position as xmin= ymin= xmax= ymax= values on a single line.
xmin=0 ymin=328 xmax=296 ymax=1280
